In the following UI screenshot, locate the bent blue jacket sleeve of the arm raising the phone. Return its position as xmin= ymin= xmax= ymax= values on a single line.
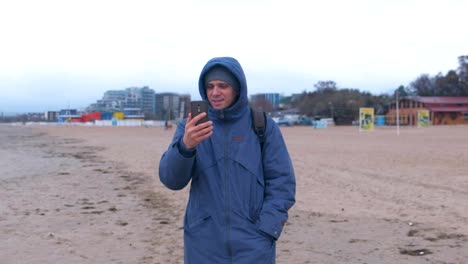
xmin=159 ymin=120 xmax=196 ymax=190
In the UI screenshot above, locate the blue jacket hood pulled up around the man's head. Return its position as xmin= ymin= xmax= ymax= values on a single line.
xmin=198 ymin=57 xmax=249 ymax=120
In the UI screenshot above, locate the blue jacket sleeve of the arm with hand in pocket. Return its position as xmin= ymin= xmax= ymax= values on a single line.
xmin=257 ymin=119 xmax=296 ymax=240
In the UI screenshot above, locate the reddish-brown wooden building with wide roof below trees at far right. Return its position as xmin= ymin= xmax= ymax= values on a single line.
xmin=386 ymin=96 xmax=468 ymax=125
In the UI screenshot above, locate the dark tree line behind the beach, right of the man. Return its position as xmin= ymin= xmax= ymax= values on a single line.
xmin=272 ymin=55 xmax=468 ymax=125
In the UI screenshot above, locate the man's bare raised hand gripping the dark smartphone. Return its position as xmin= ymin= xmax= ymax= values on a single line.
xmin=182 ymin=112 xmax=213 ymax=149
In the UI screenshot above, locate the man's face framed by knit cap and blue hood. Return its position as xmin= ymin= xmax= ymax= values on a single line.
xmin=206 ymin=80 xmax=236 ymax=109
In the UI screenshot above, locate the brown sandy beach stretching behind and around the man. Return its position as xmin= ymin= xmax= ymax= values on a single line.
xmin=0 ymin=125 xmax=468 ymax=264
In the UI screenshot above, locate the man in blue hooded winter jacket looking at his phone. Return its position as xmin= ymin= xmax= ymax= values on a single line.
xmin=159 ymin=57 xmax=296 ymax=264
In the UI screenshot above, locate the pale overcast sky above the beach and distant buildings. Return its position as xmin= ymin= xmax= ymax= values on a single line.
xmin=0 ymin=0 xmax=468 ymax=113
